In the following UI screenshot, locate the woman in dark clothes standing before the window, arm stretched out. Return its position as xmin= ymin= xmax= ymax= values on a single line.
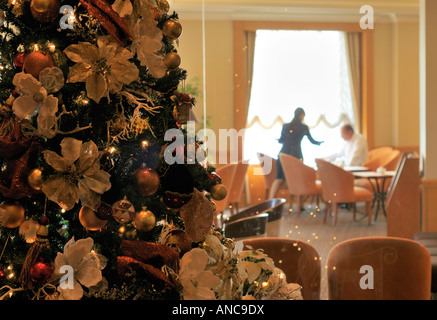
xmin=269 ymin=108 xmax=322 ymax=199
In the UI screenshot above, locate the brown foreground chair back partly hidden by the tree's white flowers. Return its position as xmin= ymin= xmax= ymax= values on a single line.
xmin=243 ymin=238 xmax=321 ymax=300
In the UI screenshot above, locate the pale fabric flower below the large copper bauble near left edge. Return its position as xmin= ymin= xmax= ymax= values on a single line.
xmin=12 ymin=72 xmax=58 ymax=139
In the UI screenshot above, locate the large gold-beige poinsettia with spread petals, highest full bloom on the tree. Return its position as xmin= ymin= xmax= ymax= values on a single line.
xmin=64 ymin=36 xmax=139 ymax=103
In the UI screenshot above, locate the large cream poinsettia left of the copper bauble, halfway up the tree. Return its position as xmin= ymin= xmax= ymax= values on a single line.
xmin=42 ymin=137 xmax=111 ymax=210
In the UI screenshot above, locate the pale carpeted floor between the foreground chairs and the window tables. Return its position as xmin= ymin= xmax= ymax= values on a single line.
xmin=225 ymin=204 xmax=386 ymax=300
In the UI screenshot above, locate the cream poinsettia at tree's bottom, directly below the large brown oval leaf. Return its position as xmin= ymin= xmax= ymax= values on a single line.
xmin=179 ymin=248 xmax=220 ymax=300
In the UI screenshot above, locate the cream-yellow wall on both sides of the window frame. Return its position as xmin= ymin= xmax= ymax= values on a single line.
xmin=175 ymin=15 xmax=419 ymax=151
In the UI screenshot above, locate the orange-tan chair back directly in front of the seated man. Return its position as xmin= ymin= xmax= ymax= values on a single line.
xmin=316 ymin=159 xmax=355 ymax=203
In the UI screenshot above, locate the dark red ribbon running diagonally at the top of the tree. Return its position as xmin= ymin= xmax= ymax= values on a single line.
xmin=80 ymin=0 xmax=132 ymax=47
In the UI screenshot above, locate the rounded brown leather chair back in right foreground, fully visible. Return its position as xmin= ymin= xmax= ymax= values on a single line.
xmin=327 ymin=237 xmax=431 ymax=300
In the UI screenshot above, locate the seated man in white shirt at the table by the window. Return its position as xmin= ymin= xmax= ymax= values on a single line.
xmin=325 ymin=124 xmax=369 ymax=167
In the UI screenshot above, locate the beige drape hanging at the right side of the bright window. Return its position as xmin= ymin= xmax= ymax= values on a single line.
xmin=344 ymin=32 xmax=362 ymax=132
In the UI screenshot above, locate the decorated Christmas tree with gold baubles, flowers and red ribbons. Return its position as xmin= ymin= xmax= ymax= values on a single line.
xmin=0 ymin=0 xmax=295 ymax=300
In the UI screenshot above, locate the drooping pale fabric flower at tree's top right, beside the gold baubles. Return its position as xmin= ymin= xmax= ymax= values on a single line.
xmin=113 ymin=0 xmax=167 ymax=78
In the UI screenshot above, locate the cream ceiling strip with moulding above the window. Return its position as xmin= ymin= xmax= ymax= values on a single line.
xmin=169 ymin=0 xmax=420 ymax=22
